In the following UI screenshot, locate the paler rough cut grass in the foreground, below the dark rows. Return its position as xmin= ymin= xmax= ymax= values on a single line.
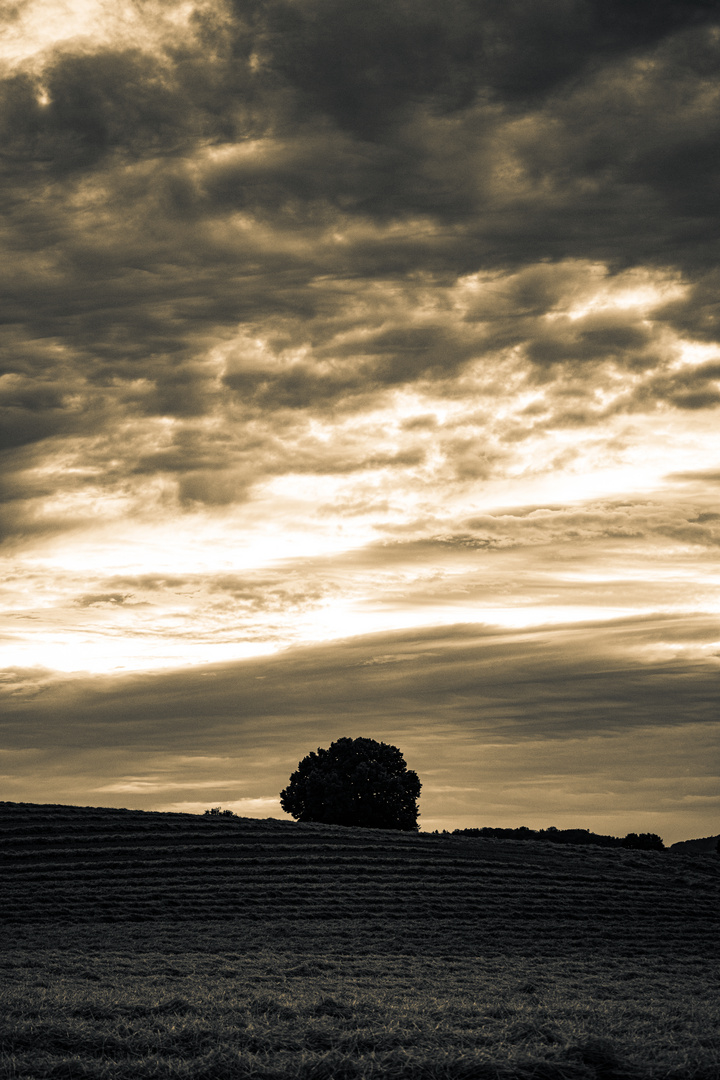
xmin=0 ymin=936 xmax=720 ymax=1080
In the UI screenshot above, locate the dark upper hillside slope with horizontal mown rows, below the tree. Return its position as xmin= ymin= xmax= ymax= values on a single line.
xmin=0 ymin=802 xmax=720 ymax=954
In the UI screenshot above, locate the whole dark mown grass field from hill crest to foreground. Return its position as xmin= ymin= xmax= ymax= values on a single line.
xmin=0 ymin=804 xmax=720 ymax=1080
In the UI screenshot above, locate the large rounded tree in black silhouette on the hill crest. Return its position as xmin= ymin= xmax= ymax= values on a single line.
xmin=280 ymin=739 xmax=422 ymax=833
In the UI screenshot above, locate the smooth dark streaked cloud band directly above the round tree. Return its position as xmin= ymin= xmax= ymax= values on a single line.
xmin=5 ymin=616 xmax=718 ymax=754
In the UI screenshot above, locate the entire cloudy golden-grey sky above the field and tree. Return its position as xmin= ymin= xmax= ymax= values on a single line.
xmin=0 ymin=0 xmax=720 ymax=842
